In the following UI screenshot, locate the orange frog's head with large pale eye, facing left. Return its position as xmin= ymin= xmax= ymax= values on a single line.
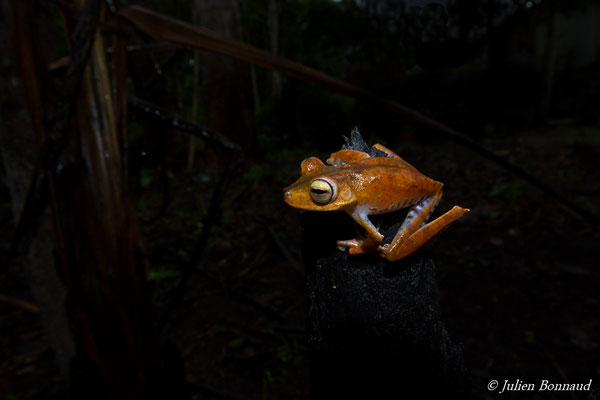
xmin=283 ymin=157 xmax=355 ymax=211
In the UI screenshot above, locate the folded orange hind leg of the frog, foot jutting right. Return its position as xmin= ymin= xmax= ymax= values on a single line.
xmin=379 ymin=190 xmax=469 ymax=261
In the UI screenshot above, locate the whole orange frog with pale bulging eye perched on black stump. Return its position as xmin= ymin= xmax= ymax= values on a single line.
xmin=283 ymin=143 xmax=470 ymax=262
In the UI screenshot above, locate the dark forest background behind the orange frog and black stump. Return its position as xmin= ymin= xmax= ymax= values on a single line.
xmin=0 ymin=0 xmax=600 ymax=400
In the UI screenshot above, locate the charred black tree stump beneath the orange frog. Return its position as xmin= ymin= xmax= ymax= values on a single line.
xmin=302 ymin=130 xmax=470 ymax=399
